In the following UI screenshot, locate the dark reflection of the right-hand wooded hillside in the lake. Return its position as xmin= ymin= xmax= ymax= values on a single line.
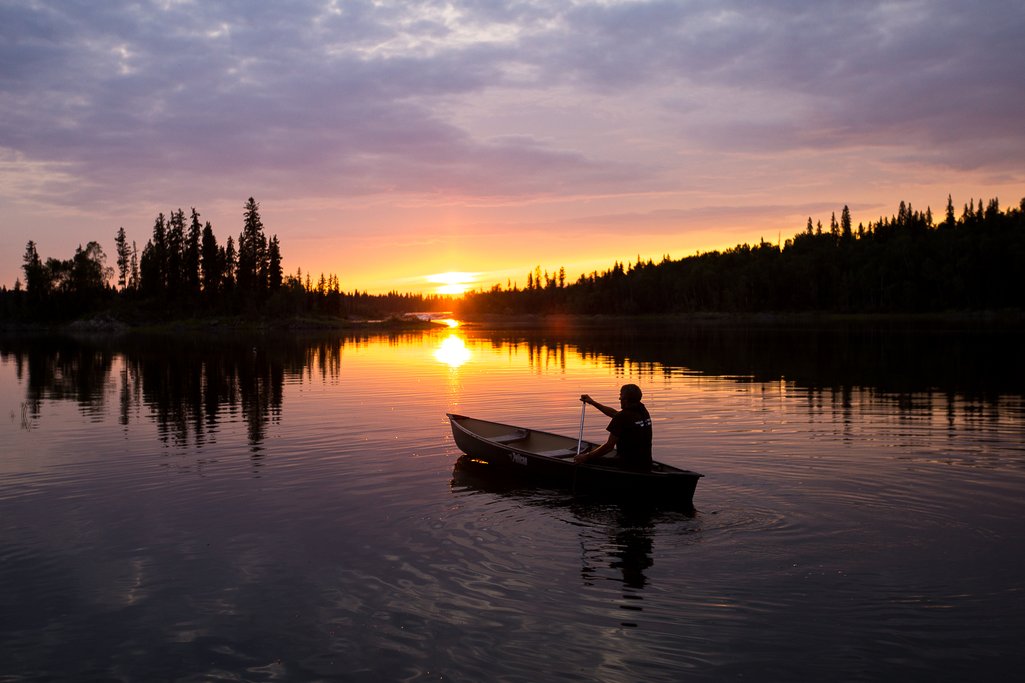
xmin=481 ymin=323 xmax=1025 ymax=425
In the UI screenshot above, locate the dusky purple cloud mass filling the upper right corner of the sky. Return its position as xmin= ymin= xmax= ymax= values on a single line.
xmin=489 ymin=0 xmax=1025 ymax=167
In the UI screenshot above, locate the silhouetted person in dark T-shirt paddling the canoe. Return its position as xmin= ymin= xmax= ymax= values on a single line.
xmin=573 ymin=385 xmax=651 ymax=471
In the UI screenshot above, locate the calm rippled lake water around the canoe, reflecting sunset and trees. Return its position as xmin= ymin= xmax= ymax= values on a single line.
xmin=0 ymin=326 xmax=1025 ymax=682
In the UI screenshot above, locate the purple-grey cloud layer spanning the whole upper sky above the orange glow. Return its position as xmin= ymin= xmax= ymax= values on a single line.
xmin=0 ymin=0 xmax=1025 ymax=225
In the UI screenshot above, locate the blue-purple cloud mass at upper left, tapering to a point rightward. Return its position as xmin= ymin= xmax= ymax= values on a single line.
xmin=0 ymin=3 xmax=656 ymax=207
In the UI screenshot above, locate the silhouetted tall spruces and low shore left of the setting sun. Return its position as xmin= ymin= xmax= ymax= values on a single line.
xmin=0 ymin=197 xmax=447 ymax=322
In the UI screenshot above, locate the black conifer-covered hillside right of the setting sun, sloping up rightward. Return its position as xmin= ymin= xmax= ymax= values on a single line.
xmin=457 ymin=196 xmax=1025 ymax=315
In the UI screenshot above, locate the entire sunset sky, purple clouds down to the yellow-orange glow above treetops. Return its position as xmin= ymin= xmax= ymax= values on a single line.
xmin=0 ymin=0 xmax=1025 ymax=293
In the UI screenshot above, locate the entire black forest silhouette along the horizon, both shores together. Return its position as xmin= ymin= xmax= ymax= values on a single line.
xmin=0 ymin=191 xmax=1025 ymax=324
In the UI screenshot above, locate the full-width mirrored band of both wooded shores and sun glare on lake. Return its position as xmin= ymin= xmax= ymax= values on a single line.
xmin=0 ymin=325 xmax=1025 ymax=452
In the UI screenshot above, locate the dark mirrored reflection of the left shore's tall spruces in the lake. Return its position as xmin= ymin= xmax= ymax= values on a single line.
xmin=0 ymin=336 xmax=360 ymax=450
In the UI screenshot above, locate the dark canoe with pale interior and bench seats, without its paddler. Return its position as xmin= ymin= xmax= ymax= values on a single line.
xmin=448 ymin=414 xmax=702 ymax=505
